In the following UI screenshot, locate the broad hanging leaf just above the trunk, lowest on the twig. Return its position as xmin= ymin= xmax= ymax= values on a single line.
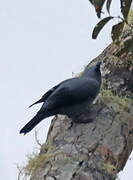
xmin=111 ymin=21 xmax=124 ymax=41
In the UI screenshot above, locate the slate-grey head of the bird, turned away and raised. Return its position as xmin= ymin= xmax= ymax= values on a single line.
xmin=82 ymin=61 xmax=101 ymax=82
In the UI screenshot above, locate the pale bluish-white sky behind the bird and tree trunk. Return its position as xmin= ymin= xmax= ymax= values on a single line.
xmin=0 ymin=0 xmax=133 ymax=180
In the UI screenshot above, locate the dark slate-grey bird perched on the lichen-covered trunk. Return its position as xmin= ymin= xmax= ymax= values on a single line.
xmin=20 ymin=61 xmax=102 ymax=135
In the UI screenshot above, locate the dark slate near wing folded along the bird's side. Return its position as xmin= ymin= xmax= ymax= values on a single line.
xmin=40 ymin=78 xmax=98 ymax=111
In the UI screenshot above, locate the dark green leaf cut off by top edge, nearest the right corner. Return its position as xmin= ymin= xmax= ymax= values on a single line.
xmin=120 ymin=0 xmax=132 ymax=20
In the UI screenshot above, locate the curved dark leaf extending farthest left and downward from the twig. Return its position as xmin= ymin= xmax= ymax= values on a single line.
xmin=92 ymin=16 xmax=114 ymax=39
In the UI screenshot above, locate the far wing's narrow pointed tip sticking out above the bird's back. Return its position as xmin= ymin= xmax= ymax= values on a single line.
xmin=29 ymin=84 xmax=60 ymax=108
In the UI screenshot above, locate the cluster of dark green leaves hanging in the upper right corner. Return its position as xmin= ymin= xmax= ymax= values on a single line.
xmin=89 ymin=0 xmax=133 ymax=41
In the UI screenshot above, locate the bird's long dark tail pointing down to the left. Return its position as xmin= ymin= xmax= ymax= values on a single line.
xmin=20 ymin=113 xmax=47 ymax=135
